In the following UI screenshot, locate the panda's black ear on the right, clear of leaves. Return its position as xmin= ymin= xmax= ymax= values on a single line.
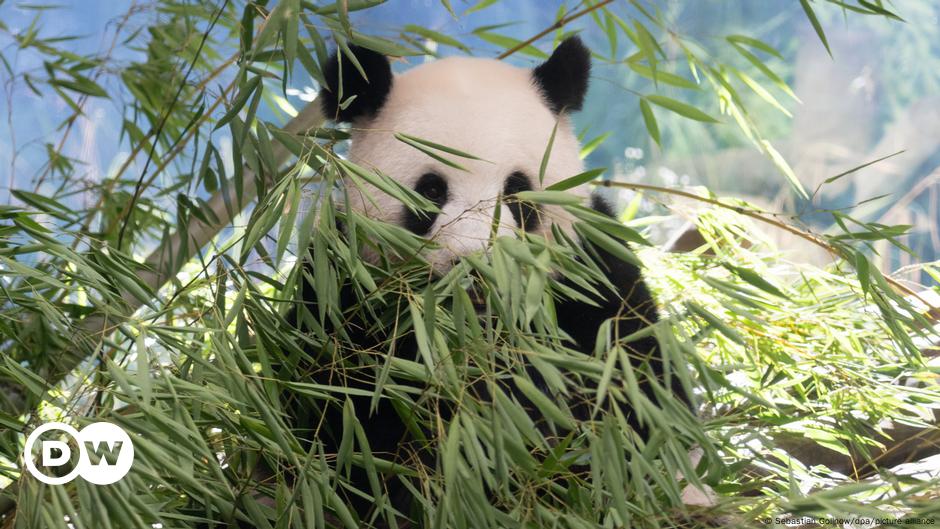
xmin=532 ymin=36 xmax=591 ymax=114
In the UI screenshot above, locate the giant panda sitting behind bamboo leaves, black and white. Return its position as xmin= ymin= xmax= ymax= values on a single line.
xmin=291 ymin=37 xmax=688 ymax=520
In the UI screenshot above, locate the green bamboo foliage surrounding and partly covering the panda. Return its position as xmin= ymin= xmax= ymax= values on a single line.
xmin=0 ymin=0 xmax=940 ymax=529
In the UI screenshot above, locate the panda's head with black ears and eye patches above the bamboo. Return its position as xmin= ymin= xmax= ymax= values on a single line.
xmin=320 ymin=37 xmax=590 ymax=271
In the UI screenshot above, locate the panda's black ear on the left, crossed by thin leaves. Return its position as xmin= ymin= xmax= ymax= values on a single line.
xmin=318 ymin=45 xmax=392 ymax=121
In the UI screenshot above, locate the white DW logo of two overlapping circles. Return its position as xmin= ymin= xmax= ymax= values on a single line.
xmin=23 ymin=422 xmax=134 ymax=485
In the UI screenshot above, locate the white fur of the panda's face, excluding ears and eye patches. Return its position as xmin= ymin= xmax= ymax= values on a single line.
xmin=349 ymin=57 xmax=589 ymax=269
